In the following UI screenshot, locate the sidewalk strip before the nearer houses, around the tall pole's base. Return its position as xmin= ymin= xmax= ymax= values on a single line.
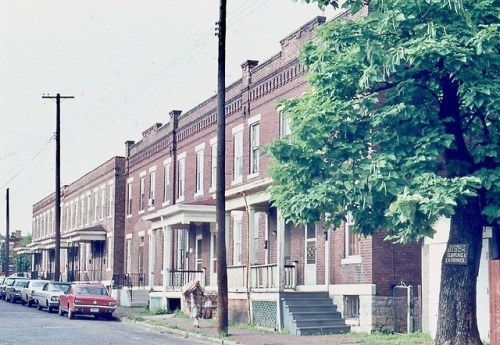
xmin=115 ymin=308 xmax=368 ymax=345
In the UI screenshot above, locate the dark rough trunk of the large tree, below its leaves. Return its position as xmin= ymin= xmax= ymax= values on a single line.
xmin=435 ymin=197 xmax=483 ymax=345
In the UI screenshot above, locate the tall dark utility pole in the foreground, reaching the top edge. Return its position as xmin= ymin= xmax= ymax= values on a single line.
xmin=215 ymin=0 xmax=229 ymax=334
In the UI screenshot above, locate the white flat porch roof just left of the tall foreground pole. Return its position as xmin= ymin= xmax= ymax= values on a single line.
xmin=142 ymin=200 xmax=216 ymax=229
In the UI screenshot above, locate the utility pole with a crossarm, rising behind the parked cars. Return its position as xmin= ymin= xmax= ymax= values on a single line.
xmin=42 ymin=94 xmax=75 ymax=281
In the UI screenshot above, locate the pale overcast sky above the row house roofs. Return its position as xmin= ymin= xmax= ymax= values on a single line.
xmin=0 ymin=0 xmax=340 ymax=235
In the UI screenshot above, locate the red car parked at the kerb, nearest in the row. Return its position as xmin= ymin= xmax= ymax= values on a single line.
xmin=59 ymin=284 xmax=117 ymax=320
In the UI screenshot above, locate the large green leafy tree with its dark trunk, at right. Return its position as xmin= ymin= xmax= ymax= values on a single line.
xmin=269 ymin=0 xmax=500 ymax=344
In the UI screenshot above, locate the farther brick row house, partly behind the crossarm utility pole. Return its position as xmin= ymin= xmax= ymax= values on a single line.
xmin=28 ymin=157 xmax=125 ymax=285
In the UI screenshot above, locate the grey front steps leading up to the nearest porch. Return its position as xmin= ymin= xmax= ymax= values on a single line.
xmin=280 ymin=292 xmax=350 ymax=335
